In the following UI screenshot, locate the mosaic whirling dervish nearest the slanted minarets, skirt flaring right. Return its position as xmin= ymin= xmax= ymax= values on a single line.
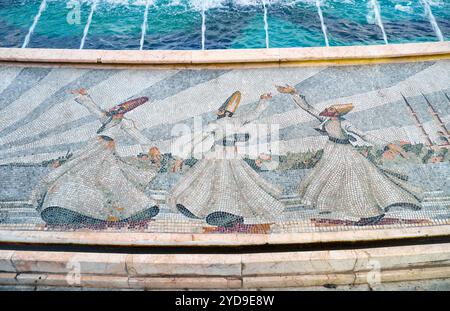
xmin=277 ymin=86 xmax=423 ymax=226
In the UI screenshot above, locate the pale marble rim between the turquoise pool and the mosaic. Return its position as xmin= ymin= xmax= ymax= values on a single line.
xmin=0 ymin=42 xmax=450 ymax=67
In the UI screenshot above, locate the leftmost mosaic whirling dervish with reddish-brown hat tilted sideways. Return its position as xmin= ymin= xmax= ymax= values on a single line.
xmin=32 ymin=89 xmax=159 ymax=228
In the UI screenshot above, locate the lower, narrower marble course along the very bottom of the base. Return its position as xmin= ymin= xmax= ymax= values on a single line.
xmin=0 ymin=267 xmax=450 ymax=290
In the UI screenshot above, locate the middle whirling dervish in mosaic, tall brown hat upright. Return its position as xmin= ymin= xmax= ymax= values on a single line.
xmin=168 ymin=91 xmax=284 ymax=228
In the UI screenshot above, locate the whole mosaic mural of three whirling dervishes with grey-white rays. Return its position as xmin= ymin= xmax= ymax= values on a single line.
xmin=0 ymin=61 xmax=450 ymax=233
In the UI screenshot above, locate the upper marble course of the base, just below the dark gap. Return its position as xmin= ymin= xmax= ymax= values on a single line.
xmin=0 ymin=243 xmax=450 ymax=277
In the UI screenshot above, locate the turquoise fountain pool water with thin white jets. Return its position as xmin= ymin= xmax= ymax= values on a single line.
xmin=0 ymin=0 xmax=450 ymax=50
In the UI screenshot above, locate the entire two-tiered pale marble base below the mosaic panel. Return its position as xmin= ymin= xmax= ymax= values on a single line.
xmin=0 ymin=244 xmax=450 ymax=290
